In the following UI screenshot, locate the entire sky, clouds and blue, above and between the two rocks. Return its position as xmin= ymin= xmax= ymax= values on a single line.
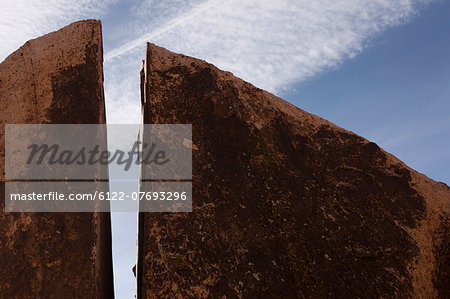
xmin=0 ymin=0 xmax=450 ymax=298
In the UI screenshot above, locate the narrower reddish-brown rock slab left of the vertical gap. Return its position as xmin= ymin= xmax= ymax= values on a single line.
xmin=0 ymin=20 xmax=113 ymax=298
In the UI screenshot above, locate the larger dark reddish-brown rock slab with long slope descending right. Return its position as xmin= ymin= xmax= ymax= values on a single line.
xmin=137 ymin=44 xmax=450 ymax=298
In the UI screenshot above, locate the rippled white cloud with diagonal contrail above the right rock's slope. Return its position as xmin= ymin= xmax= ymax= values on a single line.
xmin=105 ymin=0 xmax=426 ymax=92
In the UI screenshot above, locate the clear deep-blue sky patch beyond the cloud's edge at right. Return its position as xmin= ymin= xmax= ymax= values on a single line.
xmin=279 ymin=1 xmax=450 ymax=184
